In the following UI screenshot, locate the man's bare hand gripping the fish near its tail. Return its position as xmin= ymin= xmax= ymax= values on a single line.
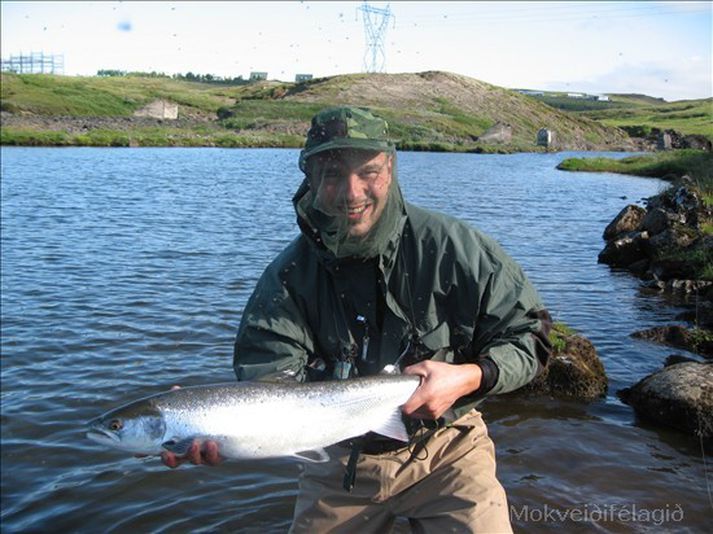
xmin=401 ymin=360 xmax=483 ymax=419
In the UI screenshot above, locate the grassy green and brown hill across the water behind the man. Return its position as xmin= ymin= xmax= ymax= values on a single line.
xmin=0 ymin=72 xmax=628 ymax=151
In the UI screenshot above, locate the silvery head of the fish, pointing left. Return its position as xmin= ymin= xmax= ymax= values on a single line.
xmin=87 ymin=400 xmax=166 ymax=454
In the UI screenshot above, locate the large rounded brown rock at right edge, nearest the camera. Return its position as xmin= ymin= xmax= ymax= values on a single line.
xmin=618 ymin=362 xmax=713 ymax=439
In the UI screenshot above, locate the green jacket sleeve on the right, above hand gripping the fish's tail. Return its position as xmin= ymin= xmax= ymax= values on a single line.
xmin=472 ymin=239 xmax=552 ymax=397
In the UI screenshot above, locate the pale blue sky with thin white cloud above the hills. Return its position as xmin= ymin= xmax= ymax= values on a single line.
xmin=0 ymin=0 xmax=713 ymax=100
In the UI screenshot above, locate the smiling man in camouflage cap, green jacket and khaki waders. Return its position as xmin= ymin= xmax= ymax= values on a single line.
xmin=164 ymin=107 xmax=551 ymax=532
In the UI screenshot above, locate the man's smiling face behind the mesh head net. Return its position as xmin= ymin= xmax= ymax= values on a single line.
xmin=310 ymin=150 xmax=392 ymax=237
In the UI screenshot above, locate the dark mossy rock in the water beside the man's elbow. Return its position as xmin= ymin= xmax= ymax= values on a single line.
xmin=518 ymin=334 xmax=608 ymax=401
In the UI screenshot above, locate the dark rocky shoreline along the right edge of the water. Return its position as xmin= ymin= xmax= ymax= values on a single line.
xmin=599 ymin=177 xmax=713 ymax=439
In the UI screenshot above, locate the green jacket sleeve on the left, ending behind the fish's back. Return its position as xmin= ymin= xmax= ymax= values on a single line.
xmin=233 ymin=262 xmax=314 ymax=381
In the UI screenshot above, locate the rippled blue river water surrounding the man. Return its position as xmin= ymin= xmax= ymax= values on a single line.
xmin=1 ymin=148 xmax=713 ymax=533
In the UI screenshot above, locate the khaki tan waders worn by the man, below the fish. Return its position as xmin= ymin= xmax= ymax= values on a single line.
xmin=290 ymin=410 xmax=512 ymax=534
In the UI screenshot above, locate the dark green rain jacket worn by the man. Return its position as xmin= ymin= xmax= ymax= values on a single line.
xmin=233 ymin=184 xmax=551 ymax=416
